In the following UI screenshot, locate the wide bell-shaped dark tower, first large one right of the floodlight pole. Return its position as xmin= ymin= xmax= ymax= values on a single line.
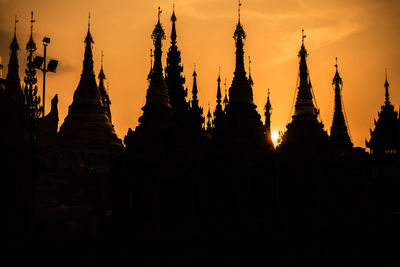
xmin=58 ymin=16 xmax=122 ymax=151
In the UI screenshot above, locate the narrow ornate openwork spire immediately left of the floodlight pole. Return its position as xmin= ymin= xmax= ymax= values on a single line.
xmin=24 ymin=12 xmax=42 ymax=118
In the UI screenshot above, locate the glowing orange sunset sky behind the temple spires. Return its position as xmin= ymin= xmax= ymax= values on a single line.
xmin=0 ymin=0 xmax=400 ymax=147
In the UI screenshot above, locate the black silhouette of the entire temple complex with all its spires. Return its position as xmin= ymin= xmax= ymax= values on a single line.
xmin=0 ymin=3 xmax=400 ymax=266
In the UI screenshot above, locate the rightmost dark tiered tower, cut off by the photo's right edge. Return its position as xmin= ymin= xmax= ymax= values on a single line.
xmin=365 ymin=73 xmax=400 ymax=159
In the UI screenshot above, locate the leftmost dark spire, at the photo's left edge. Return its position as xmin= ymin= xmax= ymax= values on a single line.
xmin=6 ymin=16 xmax=21 ymax=92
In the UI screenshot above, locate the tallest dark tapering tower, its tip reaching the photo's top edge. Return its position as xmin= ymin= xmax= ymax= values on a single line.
xmin=220 ymin=1 xmax=265 ymax=149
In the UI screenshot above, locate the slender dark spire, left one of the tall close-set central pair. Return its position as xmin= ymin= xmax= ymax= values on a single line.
xmin=143 ymin=7 xmax=171 ymax=112
